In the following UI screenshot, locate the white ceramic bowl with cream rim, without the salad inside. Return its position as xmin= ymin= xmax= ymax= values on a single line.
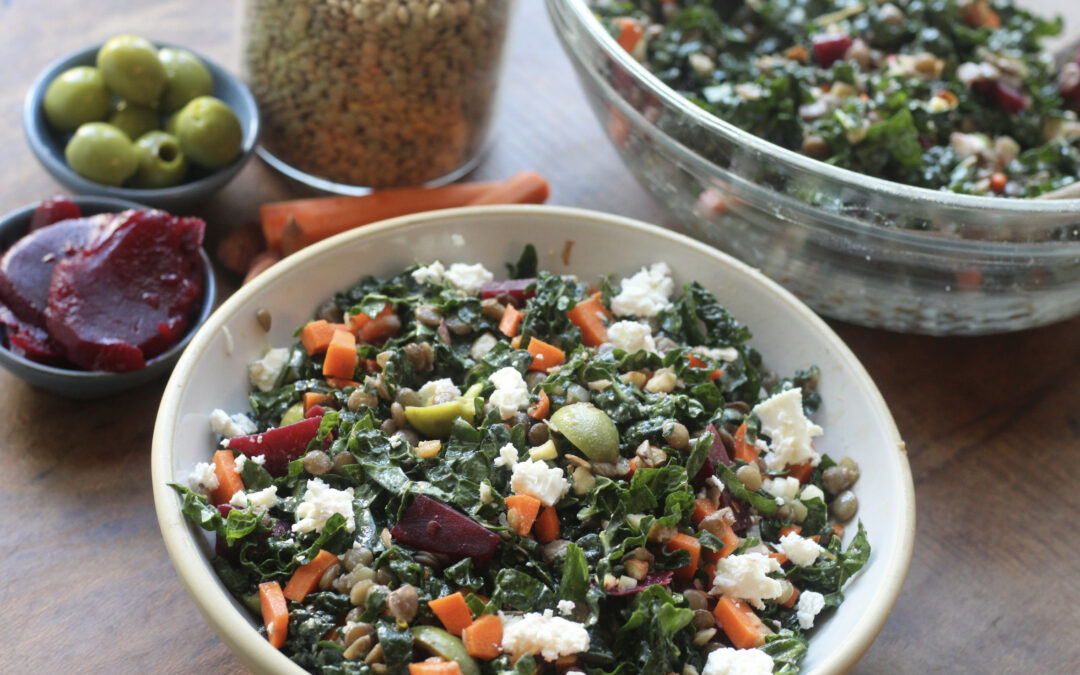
xmin=151 ymin=206 xmax=915 ymax=674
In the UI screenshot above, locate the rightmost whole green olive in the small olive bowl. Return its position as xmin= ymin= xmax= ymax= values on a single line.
xmin=168 ymin=96 xmax=244 ymax=168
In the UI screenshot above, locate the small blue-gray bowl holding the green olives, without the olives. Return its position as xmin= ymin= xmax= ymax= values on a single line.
xmin=23 ymin=44 xmax=259 ymax=211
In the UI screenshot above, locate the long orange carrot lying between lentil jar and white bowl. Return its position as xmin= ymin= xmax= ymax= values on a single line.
xmin=259 ymin=181 xmax=502 ymax=251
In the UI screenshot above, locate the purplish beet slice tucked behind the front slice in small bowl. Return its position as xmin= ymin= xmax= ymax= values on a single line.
xmin=0 ymin=214 xmax=113 ymax=327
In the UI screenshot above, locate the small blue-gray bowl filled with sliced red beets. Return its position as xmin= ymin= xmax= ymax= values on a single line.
xmin=0 ymin=197 xmax=215 ymax=399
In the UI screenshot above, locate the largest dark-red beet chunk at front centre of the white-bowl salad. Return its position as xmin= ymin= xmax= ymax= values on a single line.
xmin=390 ymin=495 xmax=501 ymax=565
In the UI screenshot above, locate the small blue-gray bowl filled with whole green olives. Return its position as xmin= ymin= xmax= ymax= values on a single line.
xmin=23 ymin=36 xmax=259 ymax=211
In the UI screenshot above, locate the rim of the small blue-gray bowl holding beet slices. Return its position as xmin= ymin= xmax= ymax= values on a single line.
xmin=0 ymin=194 xmax=217 ymax=383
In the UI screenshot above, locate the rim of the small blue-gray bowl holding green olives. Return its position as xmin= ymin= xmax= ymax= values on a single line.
xmin=23 ymin=40 xmax=262 ymax=202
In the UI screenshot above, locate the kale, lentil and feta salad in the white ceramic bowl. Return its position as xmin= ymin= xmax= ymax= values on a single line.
xmin=173 ymin=246 xmax=870 ymax=675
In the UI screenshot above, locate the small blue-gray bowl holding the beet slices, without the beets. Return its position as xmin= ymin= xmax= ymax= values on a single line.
xmin=0 ymin=197 xmax=216 ymax=399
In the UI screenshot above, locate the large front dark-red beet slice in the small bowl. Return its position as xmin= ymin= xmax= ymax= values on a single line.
xmin=42 ymin=211 xmax=206 ymax=373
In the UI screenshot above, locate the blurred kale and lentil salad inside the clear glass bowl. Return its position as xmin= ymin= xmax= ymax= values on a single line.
xmin=591 ymin=0 xmax=1080 ymax=198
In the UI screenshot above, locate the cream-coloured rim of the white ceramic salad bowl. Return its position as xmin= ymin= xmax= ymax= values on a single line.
xmin=150 ymin=205 xmax=916 ymax=673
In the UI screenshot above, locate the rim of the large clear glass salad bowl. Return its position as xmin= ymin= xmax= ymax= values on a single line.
xmin=545 ymin=0 xmax=1080 ymax=216
